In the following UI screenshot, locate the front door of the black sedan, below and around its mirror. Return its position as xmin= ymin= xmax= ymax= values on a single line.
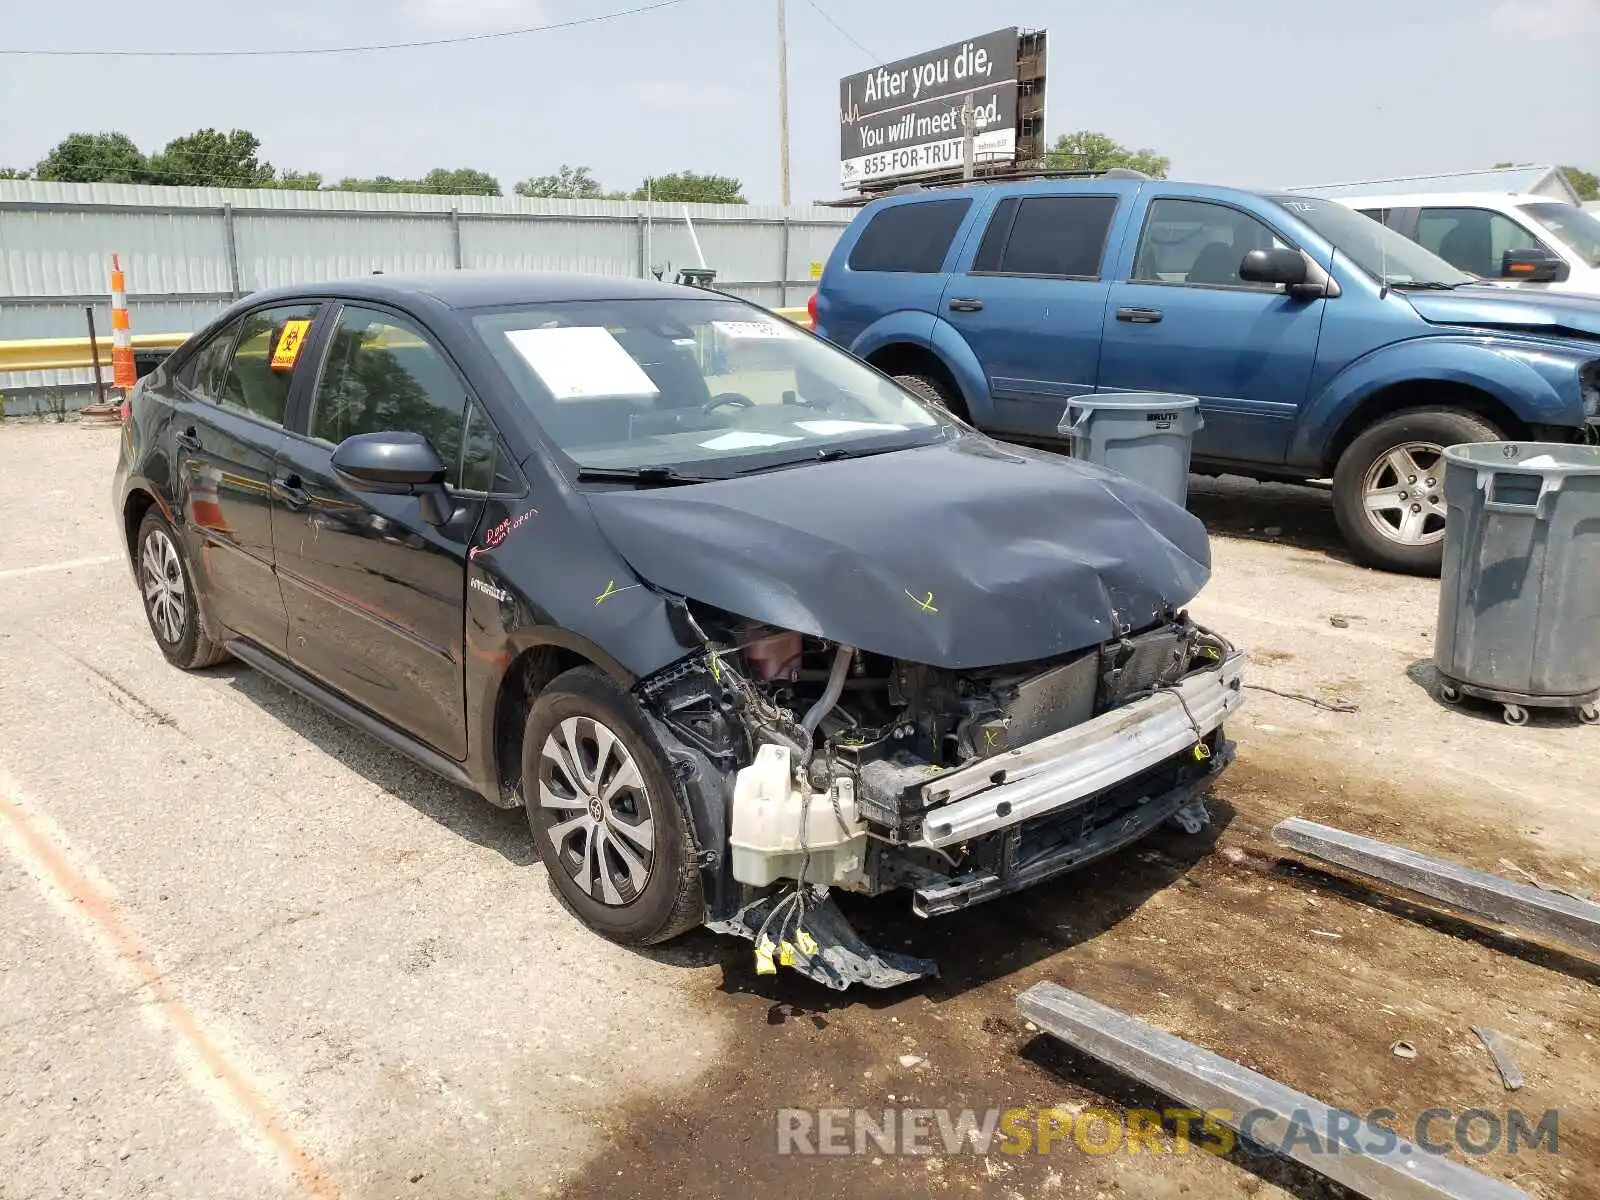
xmin=274 ymin=304 xmax=496 ymax=762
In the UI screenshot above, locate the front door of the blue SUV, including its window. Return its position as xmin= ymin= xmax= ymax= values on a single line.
xmin=1099 ymin=194 xmax=1328 ymax=464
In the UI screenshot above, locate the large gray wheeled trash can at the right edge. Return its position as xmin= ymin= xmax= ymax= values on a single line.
xmin=1434 ymin=442 xmax=1600 ymax=725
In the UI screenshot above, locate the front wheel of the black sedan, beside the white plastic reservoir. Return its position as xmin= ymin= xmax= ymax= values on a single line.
xmin=522 ymin=667 xmax=704 ymax=946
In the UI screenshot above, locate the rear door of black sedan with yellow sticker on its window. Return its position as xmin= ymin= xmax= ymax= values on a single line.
xmin=171 ymin=302 xmax=320 ymax=653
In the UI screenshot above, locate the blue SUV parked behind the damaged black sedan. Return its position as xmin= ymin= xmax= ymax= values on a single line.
xmin=813 ymin=176 xmax=1600 ymax=573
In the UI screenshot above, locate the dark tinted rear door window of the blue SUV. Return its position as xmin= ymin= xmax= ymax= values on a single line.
xmin=973 ymin=195 xmax=1117 ymax=278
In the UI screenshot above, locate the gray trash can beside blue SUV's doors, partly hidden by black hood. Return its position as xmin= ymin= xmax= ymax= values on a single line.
xmin=1056 ymin=392 xmax=1205 ymax=504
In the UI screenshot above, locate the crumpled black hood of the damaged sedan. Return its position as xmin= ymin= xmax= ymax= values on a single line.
xmin=587 ymin=435 xmax=1211 ymax=670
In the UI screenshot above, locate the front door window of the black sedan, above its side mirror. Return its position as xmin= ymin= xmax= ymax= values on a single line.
xmin=310 ymin=304 xmax=467 ymax=485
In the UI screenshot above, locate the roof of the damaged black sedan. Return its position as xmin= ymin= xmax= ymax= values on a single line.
xmin=250 ymin=270 xmax=726 ymax=309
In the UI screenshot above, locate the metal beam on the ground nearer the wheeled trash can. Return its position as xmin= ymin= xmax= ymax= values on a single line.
xmin=1272 ymin=818 xmax=1600 ymax=957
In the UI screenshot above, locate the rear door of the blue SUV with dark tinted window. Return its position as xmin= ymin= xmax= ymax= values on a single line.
xmin=941 ymin=192 xmax=1118 ymax=437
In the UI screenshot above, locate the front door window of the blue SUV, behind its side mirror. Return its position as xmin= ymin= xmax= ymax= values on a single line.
xmin=1133 ymin=200 xmax=1288 ymax=291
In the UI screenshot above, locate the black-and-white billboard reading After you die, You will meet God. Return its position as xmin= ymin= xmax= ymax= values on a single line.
xmin=838 ymin=29 xmax=1021 ymax=187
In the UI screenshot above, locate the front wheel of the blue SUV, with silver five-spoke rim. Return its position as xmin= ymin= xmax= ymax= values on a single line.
xmin=1333 ymin=408 xmax=1504 ymax=576
